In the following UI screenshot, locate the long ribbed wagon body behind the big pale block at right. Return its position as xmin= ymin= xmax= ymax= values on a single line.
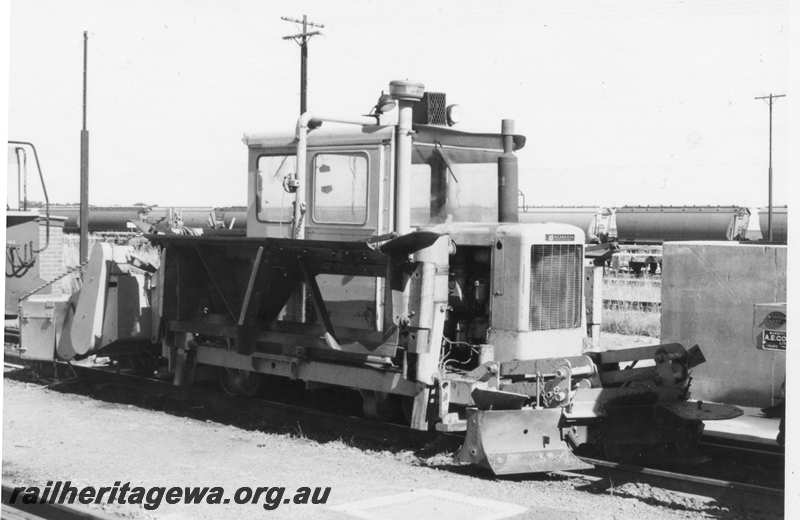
xmin=616 ymin=206 xmax=761 ymax=244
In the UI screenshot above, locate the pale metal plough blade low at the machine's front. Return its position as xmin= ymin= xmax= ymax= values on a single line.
xmin=457 ymin=408 xmax=591 ymax=475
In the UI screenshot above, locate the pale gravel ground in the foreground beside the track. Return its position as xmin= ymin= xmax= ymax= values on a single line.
xmin=3 ymin=378 xmax=780 ymax=520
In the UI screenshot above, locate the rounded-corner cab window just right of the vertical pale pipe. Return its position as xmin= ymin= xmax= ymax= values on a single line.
xmin=312 ymin=153 xmax=369 ymax=224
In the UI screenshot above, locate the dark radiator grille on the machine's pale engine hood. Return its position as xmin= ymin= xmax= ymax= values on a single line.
xmin=530 ymin=244 xmax=583 ymax=330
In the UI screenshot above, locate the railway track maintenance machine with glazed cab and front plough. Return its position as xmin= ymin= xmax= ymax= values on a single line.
xmin=23 ymin=81 xmax=740 ymax=474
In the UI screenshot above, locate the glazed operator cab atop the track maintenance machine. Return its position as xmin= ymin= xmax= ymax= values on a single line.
xmin=244 ymin=93 xmax=525 ymax=240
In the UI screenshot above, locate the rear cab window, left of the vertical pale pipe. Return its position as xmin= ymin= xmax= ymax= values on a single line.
xmin=256 ymin=155 xmax=297 ymax=222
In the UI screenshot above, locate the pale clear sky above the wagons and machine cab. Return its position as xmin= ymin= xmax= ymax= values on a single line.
xmin=8 ymin=0 xmax=795 ymax=206
